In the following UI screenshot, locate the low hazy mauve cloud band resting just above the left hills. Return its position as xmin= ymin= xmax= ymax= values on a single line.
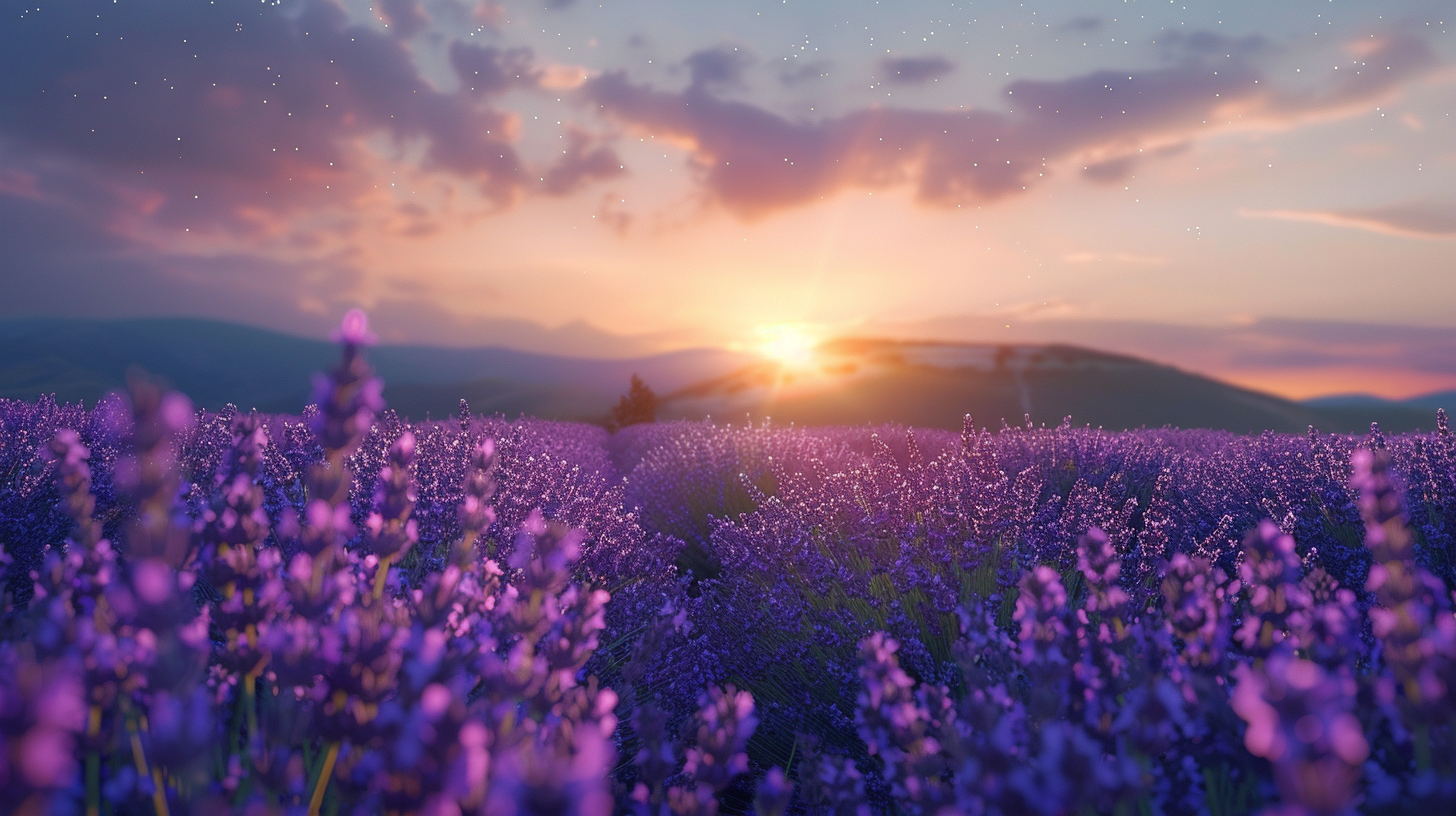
xmin=0 ymin=179 xmax=666 ymax=357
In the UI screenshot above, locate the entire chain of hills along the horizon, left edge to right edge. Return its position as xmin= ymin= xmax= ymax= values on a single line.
xmin=0 ymin=319 xmax=1456 ymax=433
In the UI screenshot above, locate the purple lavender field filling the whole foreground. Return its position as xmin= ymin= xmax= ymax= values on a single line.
xmin=0 ymin=315 xmax=1456 ymax=816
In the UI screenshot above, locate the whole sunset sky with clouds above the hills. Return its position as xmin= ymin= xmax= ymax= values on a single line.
xmin=0 ymin=0 xmax=1456 ymax=398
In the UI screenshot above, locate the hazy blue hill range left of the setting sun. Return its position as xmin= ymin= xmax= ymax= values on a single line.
xmin=0 ymin=318 xmax=756 ymax=421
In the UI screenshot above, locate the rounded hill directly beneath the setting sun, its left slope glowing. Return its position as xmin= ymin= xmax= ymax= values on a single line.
xmin=668 ymin=340 xmax=1369 ymax=433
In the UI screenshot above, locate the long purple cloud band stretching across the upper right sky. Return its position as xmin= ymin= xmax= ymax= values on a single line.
xmin=582 ymin=36 xmax=1436 ymax=219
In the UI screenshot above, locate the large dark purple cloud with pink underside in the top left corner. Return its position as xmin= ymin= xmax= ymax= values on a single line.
xmin=0 ymin=0 xmax=614 ymax=232
